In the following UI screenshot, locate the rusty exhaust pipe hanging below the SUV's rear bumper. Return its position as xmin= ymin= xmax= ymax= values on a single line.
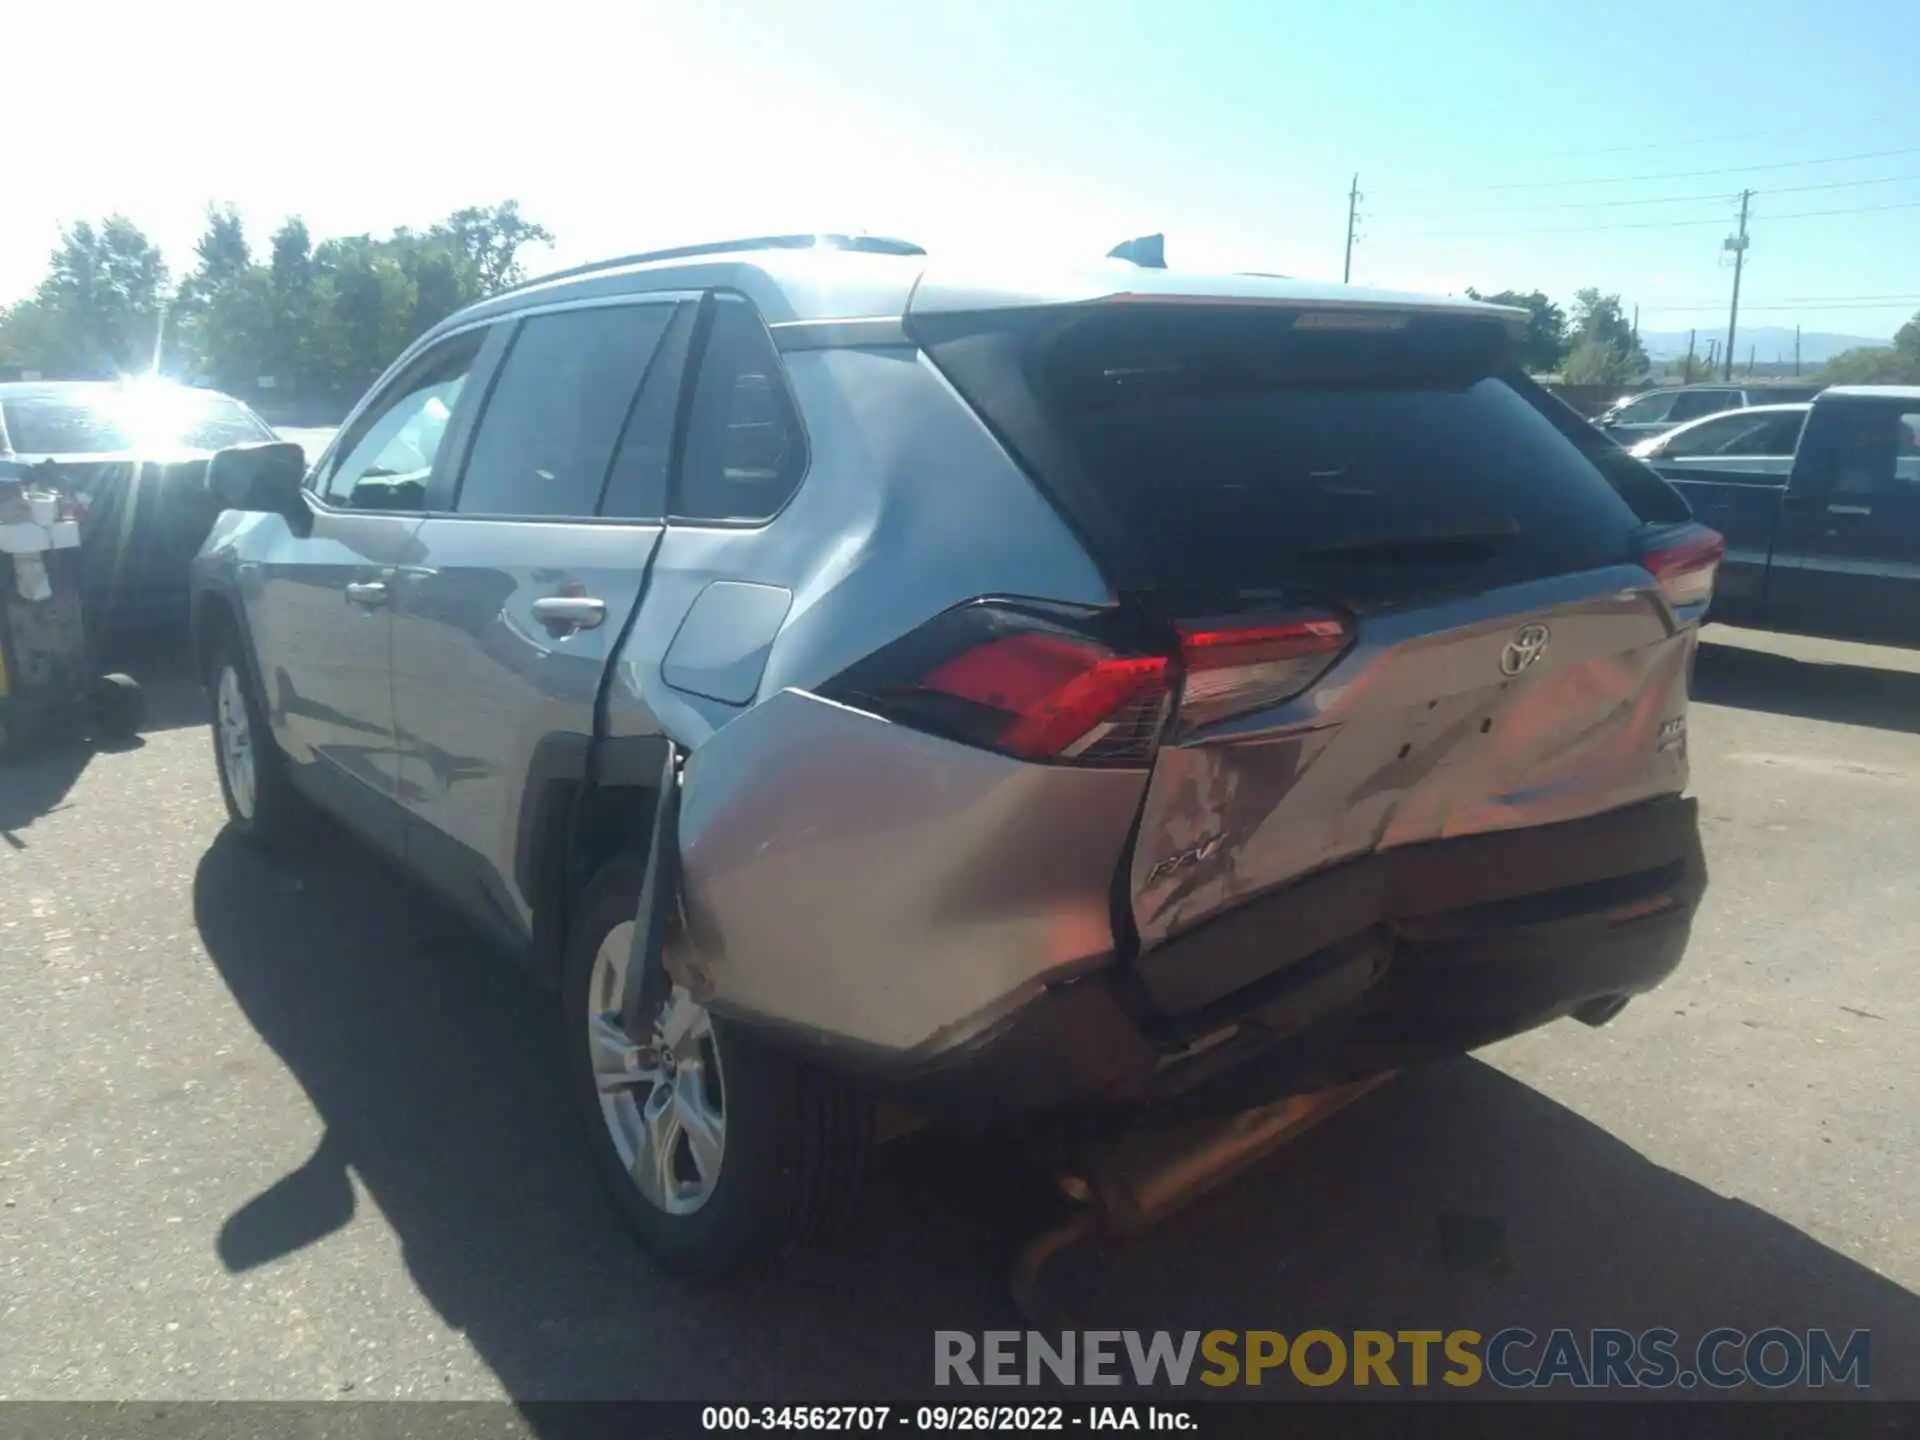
xmin=1012 ymin=1073 xmax=1392 ymax=1329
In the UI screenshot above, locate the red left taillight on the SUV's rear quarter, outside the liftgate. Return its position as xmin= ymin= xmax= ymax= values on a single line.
xmin=820 ymin=601 xmax=1173 ymax=766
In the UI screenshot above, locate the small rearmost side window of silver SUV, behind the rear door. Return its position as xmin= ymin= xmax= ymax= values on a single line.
xmin=674 ymin=296 xmax=806 ymax=524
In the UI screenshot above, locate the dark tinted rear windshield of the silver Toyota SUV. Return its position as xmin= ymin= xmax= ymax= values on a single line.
xmin=922 ymin=305 xmax=1686 ymax=607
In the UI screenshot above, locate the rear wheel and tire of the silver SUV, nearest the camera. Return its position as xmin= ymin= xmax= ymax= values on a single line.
xmin=561 ymin=862 xmax=874 ymax=1281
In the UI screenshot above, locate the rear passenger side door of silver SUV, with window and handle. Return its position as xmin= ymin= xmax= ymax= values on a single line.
xmin=394 ymin=294 xmax=693 ymax=941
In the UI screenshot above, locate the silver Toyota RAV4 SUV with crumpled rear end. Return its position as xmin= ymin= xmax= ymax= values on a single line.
xmin=192 ymin=236 xmax=1720 ymax=1273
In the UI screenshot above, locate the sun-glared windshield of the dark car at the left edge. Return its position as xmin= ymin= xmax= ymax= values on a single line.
xmin=0 ymin=392 xmax=273 ymax=455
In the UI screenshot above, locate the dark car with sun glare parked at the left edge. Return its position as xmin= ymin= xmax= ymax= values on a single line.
xmin=0 ymin=380 xmax=273 ymax=628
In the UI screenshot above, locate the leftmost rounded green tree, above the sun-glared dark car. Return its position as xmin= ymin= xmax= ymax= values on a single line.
xmin=6 ymin=215 xmax=167 ymax=380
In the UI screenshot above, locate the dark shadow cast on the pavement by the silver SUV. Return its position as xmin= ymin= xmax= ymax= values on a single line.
xmin=194 ymin=835 xmax=1920 ymax=1425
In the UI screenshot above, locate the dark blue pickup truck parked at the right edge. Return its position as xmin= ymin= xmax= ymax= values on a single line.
xmin=1647 ymin=386 xmax=1920 ymax=645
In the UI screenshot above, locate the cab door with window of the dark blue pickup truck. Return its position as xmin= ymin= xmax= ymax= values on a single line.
xmin=1768 ymin=397 xmax=1920 ymax=643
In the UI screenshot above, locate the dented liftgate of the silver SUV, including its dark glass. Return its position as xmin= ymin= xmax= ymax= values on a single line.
xmin=920 ymin=301 xmax=1692 ymax=1006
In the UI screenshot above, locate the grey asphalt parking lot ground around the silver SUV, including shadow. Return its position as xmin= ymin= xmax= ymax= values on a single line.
xmin=0 ymin=632 xmax=1920 ymax=1400
